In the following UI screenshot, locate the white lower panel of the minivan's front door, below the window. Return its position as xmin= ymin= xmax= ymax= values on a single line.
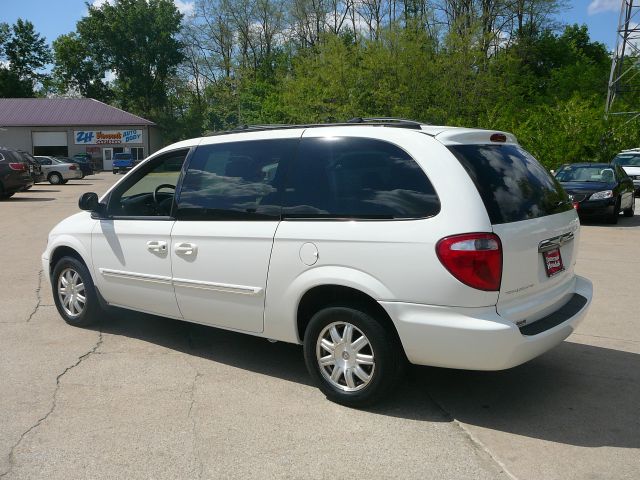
xmin=92 ymin=220 xmax=182 ymax=318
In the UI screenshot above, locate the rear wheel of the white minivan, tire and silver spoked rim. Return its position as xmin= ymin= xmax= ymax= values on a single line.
xmin=304 ymin=306 xmax=404 ymax=407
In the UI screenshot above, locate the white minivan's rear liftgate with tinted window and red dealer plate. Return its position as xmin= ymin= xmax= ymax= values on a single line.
xmin=449 ymin=143 xmax=580 ymax=325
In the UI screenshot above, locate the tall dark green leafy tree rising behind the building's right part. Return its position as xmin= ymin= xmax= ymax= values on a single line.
xmin=55 ymin=0 xmax=184 ymax=119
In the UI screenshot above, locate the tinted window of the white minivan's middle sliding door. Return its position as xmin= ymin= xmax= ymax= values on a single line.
xmin=176 ymin=138 xmax=298 ymax=220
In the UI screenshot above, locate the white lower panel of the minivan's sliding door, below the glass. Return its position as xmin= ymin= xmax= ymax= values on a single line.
xmin=171 ymin=221 xmax=278 ymax=332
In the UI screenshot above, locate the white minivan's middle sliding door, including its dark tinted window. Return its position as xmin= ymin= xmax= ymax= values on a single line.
xmin=171 ymin=134 xmax=299 ymax=332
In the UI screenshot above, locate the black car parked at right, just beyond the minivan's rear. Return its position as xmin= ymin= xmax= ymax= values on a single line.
xmin=555 ymin=163 xmax=635 ymax=223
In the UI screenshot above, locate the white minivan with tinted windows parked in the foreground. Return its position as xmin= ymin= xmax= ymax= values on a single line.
xmin=42 ymin=119 xmax=592 ymax=406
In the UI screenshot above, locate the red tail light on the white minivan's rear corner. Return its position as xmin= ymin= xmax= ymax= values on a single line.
xmin=436 ymin=233 xmax=502 ymax=291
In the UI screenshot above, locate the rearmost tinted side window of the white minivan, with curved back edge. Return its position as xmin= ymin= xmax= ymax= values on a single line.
xmin=283 ymin=137 xmax=440 ymax=219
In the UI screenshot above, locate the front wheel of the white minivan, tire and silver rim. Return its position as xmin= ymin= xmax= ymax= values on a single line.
xmin=51 ymin=257 xmax=104 ymax=327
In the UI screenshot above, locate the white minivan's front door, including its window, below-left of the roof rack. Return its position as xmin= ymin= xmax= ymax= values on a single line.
xmin=92 ymin=150 xmax=188 ymax=318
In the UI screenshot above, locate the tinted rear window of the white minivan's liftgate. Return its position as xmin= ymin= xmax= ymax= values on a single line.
xmin=449 ymin=144 xmax=573 ymax=225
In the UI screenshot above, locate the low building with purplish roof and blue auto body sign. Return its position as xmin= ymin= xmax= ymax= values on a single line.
xmin=0 ymin=98 xmax=163 ymax=170
